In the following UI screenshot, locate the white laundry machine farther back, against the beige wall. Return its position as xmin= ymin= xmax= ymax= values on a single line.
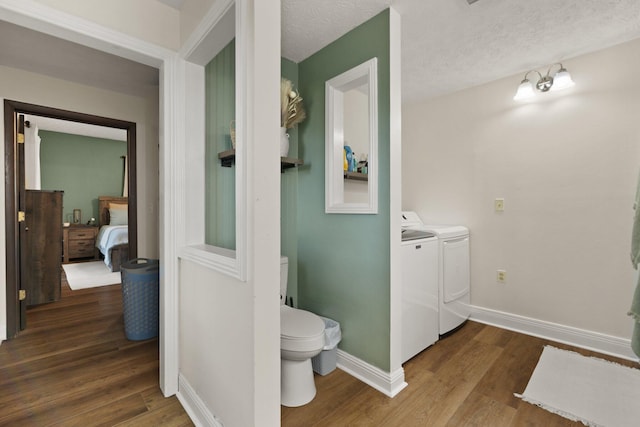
xmin=402 ymin=211 xmax=471 ymax=335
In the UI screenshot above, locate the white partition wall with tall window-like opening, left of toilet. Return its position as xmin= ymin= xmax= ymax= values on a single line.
xmin=178 ymin=0 xmax=281 ymax=427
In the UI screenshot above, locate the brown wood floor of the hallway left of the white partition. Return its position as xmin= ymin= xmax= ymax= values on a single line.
xmin=0 ymin=271 xmax=193 ymax=426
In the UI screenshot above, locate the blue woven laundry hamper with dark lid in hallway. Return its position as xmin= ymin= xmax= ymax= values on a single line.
xmin=120 ymin=258 xmax=160 ymax=341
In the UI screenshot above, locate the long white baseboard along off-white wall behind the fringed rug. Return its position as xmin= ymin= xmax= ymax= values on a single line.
xmin=471 ymin=306 xmax=638 ymax=361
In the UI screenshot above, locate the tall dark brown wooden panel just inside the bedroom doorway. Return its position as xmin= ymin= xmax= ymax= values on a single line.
xmin=20 ymin=190 xmax=63 ymax=306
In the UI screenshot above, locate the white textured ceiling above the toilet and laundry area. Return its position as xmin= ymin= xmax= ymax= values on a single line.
xmin=282 ymin=0 xmax=640 ymax=102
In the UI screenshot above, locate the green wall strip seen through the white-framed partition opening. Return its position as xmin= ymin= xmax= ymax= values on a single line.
xmin=204 ymin=40 xmax=236 ymax=249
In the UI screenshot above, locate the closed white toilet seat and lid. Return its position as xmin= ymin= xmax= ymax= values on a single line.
xmin=280 ymin=305 xmax=325 ymax=351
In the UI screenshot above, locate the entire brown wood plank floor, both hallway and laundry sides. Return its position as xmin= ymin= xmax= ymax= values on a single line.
xmin=0 ymin=272 xmax=638 ymax=427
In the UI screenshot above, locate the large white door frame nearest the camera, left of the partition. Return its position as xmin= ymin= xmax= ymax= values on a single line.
xmin=0 ymin=0 xmax=180 ymax=396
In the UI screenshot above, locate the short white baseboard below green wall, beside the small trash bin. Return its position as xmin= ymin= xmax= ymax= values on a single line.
xmin=337 ymin=349 xmax=407 ymax=397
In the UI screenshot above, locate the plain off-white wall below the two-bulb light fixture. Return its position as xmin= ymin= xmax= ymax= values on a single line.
xmin=402 ymin=40 xmax=640 ymax=338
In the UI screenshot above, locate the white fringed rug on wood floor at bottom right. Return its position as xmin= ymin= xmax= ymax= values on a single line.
xmin=516 ymin=346 xmax=640 ymax=427
